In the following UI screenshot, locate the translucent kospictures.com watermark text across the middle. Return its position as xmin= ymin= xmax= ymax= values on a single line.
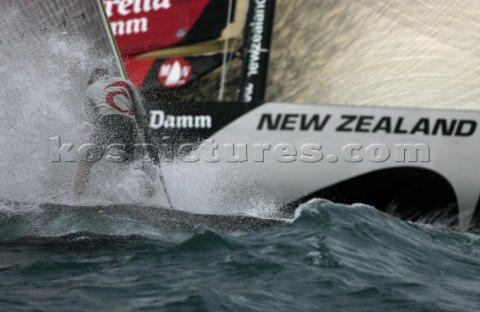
xmin=50 ymin=137 xmax=430 ymax=163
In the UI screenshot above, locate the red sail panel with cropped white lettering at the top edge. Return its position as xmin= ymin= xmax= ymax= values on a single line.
xmin=104 ymin=0 xmax=210 ymax=57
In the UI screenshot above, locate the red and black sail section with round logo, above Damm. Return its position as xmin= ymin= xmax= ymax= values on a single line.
xmin=104 ymin=0 xmax=249 ymax=102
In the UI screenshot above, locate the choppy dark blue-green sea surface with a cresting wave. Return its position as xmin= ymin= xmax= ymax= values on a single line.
xmin=0 ymin=200 xmax=480 ymax=311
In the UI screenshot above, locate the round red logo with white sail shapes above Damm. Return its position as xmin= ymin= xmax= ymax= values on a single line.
xmin=158 ymin=58 xmax=192 ymax=89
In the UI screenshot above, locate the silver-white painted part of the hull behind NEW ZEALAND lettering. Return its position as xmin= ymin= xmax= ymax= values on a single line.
xmin=192 ymin=103 xmax=480 ymax=228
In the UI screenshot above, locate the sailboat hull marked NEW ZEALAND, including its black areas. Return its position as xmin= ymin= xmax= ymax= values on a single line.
xmin=145 ymin=103 xmax=480 ymax=228
